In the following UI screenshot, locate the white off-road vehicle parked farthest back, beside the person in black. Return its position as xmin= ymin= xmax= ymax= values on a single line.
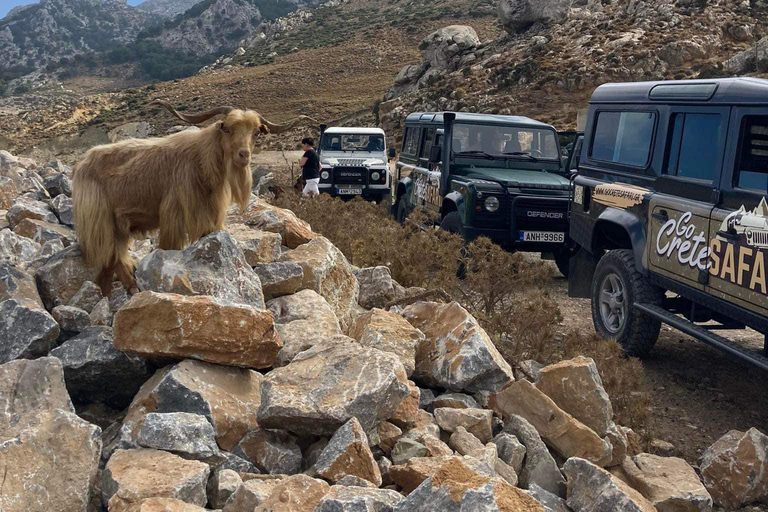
xmin=318 ymin=127 xmax=395 ymax=202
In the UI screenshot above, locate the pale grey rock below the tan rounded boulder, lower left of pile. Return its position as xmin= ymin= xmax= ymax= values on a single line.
xmin=137 ymin=412 xmax=219 ymax=461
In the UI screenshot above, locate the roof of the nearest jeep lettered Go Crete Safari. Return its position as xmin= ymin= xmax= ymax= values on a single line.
xmin=589 ymin=77 xmax=768 ymax=105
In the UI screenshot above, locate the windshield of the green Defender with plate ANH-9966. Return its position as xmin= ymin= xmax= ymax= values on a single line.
xmin=453 ymin=124 xmax=560 ymax=160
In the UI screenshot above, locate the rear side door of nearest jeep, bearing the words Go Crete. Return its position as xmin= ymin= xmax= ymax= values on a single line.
xmin=648 ymin=107 xmax=729 ymax=290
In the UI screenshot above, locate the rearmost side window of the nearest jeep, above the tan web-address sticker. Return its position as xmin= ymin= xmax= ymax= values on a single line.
xmin=590 ymin=112 xmax=656 ymax=167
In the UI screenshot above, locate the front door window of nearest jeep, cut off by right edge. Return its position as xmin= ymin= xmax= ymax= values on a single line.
xmin=734 ymin=116 xmax=768 ymax=194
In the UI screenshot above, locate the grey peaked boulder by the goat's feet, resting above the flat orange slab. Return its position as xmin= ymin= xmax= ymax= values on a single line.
xmin=136 ymin=231 xmax=264 ymax=309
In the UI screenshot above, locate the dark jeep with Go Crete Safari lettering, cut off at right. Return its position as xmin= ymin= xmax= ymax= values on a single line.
xmin=569 ymin=78 xmax=768 ymax=370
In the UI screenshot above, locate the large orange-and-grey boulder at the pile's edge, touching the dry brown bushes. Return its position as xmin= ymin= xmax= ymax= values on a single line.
xmin=403 ymin=302 xmax=514 ymax=392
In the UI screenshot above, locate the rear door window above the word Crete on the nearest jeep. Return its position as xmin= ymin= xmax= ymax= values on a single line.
xmin=664 ymin=113 xmax=723 ymax=183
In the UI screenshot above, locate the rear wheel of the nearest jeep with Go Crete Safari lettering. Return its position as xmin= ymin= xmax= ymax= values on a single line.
xmin=592 ymin=249 xmax=662 ymax=357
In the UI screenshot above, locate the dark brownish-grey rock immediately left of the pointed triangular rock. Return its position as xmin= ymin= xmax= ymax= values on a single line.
xmin=234 ymin=428 xmax=301 ymax=475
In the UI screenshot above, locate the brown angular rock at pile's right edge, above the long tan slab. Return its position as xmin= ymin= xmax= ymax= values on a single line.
xmin=536 ymin=356 xmax=613 ymax=437
